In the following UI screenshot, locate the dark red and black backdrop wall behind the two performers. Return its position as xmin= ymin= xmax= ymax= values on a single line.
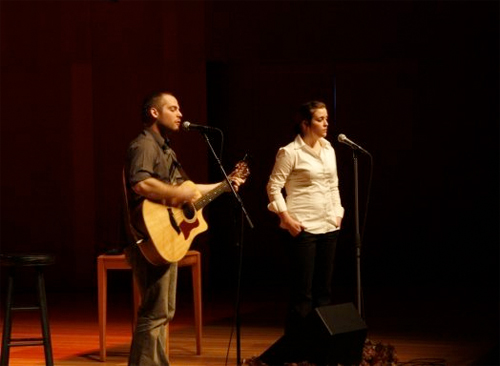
xmin=0 ymin=0 xmax=499 ymax=320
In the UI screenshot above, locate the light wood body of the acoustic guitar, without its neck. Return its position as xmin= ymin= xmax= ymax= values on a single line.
xmin=139 ymin=181 xmax=208 ymax=265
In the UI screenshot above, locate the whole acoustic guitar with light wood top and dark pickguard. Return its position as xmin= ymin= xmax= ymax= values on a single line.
xmin=138 ymin=160 xmax=250 ymax=265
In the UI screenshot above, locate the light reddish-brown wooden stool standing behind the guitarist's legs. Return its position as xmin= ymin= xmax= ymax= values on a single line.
xmin=97 ymin=250 xmax=202 ymax=362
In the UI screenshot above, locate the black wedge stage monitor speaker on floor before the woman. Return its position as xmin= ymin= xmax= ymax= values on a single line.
xmin=260 ymin=303 xmax=367 ymax=366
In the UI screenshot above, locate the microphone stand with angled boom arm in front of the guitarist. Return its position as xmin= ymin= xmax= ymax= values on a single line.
xmin=202 ymin=132 xmax=254 ymax=366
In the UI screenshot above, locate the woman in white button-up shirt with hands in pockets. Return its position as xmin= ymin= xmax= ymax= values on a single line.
xmin=267 ymin=101 xmax=344 ymax=335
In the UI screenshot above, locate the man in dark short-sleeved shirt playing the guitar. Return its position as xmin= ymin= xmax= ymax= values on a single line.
xmin=124 ymin=92 xmax=245 ymax=366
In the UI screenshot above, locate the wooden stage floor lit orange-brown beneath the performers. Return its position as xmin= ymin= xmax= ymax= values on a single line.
xmin=2 ymin=289 xmax=498 ymax=366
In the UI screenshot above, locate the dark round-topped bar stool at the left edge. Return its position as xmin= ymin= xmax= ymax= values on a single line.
xmin=0 ymin=254 xmax=55 ymax=366
